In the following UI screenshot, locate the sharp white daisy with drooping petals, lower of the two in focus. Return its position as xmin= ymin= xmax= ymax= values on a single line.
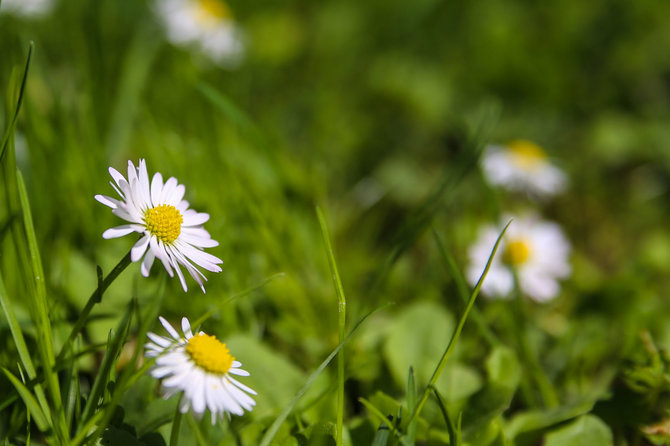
xmin=145 ymin=317 xmax=256 ymax=424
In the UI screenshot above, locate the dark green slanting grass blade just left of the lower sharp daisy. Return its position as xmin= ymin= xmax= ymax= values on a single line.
xmin=78 ymin=300 xmax=136 ymax=430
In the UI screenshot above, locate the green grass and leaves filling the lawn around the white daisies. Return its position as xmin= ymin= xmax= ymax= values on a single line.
xmin=0 ymin=0 xmax=670 ymax=446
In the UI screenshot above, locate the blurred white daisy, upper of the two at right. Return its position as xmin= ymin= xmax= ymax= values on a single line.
xmin=482 ymin=140 xmax=567 ymax=196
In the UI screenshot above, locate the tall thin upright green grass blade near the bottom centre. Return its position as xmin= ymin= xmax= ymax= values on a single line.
xmin=316 ymin=206 xmax=347 ymax=446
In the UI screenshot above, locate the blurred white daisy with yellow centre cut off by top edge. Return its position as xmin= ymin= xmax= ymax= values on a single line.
xmin=156 ymin=0 xmax=244 ymax=67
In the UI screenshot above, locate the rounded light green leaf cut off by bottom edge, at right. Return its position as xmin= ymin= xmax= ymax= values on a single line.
xmin=544 ymin=415 xmax=614 ymax=446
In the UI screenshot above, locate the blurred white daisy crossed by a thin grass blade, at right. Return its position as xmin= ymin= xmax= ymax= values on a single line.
xmin=467 ymin=217 xmax=570 ymax=302
